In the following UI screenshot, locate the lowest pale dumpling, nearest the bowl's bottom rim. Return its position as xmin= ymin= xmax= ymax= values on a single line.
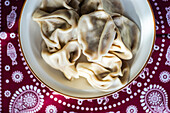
xmin=77 ymin=63 xmax=117 ymax=90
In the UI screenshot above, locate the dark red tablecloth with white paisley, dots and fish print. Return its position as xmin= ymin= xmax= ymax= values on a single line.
xmin=0 ymin=0 xmax=170 ymax=113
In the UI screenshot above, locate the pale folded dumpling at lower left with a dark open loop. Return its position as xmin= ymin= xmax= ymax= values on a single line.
xmin=41 ymin=41 xmax=81 ymax=80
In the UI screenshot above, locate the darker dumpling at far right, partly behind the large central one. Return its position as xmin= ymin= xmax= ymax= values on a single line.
xmin=113 ymin=14 xmax=140 ymax=54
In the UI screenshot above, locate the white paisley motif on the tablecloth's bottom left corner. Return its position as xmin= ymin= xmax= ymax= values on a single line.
xmin=9 ymin=85 xmax=44 ymax=113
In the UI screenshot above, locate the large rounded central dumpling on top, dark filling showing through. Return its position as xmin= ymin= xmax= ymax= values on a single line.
xmin=78 ymin=11 xmax=116 ymax=60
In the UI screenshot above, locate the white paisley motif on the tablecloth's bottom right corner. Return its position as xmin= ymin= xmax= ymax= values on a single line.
xmin=140 ymin=84 xmax=170 ymax=113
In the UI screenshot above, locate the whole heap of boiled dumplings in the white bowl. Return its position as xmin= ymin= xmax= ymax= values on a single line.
xmin=33 ymin=0 xmax=140 ymax=91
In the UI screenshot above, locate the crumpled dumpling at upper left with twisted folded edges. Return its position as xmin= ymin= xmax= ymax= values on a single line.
xmin=33 ymin=9 xmax=79 ymax=52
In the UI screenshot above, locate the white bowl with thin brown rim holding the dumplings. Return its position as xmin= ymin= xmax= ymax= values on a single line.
xmin=19 ymin=0 xmax=155 ymax=99
